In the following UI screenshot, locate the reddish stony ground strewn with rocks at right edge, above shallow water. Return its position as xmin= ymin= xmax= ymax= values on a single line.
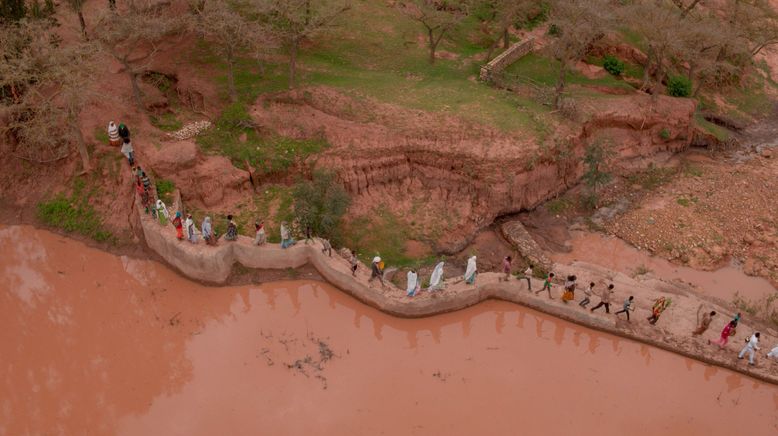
xmin=604 ymin=146 xmax=778 ymax=286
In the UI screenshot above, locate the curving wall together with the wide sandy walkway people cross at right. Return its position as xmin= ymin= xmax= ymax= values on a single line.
xmin=138 ymin=209 xmax=778 ymax=384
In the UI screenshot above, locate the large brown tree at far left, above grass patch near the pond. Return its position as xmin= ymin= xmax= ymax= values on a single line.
xmin=0 ymin=21 xmax=98 ymax=172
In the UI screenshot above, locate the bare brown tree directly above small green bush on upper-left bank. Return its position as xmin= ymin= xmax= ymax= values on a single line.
xmin=190 ymin=0 xmax=274 ymax=102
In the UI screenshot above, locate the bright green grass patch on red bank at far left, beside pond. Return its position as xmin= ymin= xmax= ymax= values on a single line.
xmin=36 ymin=179 xmax=114 ymax=242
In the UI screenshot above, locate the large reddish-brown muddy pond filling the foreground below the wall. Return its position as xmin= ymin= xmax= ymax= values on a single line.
xmin=0 ymin=227 xmax=778 ymax=436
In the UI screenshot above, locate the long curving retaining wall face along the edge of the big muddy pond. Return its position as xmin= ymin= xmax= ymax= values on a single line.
xmin=138 ymin=204 xmax=778 ymax=384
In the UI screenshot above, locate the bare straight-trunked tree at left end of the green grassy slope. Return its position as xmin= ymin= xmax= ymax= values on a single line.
xmin=252 ymin=0 xmax=351 ymax=88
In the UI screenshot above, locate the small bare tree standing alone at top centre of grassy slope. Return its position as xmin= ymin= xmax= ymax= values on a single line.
xmin=396 ymin=0 xmax=470 ymax=64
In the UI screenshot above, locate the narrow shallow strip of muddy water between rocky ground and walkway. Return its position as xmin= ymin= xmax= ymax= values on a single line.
xmin=551 ymin=232 xmax=776 ymax=301
